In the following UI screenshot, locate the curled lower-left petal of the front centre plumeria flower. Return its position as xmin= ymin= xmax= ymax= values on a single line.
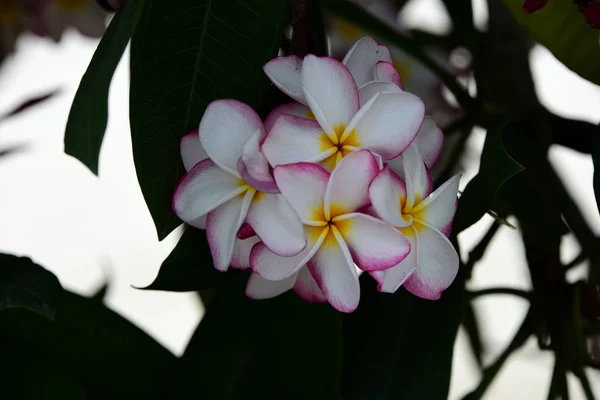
xmin=250 ymin=227 xmax=329 ymax=281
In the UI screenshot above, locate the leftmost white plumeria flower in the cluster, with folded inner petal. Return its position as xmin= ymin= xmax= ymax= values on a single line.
xmin=173 ymin=100 xmax=306 ymax=271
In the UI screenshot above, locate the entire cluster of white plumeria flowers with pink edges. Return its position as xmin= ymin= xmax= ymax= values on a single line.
xmin=173 ymin=37 xmax=459 ymax=312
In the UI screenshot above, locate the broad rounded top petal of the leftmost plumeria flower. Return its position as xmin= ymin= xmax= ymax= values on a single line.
xmin=199 ymin=99 xmax=264 ymax=176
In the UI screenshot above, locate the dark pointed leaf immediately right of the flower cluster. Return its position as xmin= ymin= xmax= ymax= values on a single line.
xmin=452 ymin=123 xmax=523 ymax=234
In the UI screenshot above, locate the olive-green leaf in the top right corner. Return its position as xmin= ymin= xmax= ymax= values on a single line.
xmin=502 ymin=0 xmax=600 ymax=84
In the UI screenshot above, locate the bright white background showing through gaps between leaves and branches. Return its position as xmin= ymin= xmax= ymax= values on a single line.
xmin=0 ymin=0 xmax=600 ymax=400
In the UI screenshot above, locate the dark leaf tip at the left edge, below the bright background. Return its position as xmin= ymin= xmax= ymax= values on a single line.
xmin=0 ymin=254 xmax=62 ymax=320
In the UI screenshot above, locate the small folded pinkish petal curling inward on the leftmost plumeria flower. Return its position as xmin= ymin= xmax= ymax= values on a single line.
xmin=237 ymin=129 xmax=279 ymax=193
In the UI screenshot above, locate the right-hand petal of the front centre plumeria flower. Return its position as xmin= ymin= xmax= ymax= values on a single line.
xmin=335 ymin=213 xmax=410 ymax=271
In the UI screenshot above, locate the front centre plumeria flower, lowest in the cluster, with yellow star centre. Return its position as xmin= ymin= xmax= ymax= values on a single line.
xmin=250 ymin=150 xmax=410 ymax=312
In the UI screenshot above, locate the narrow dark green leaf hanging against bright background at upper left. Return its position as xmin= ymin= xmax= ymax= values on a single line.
xmin=65 ymin=0 xmax=142 ymax=174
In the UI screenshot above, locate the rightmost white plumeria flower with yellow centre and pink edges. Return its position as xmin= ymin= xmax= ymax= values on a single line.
xmin=369 ymin=146 xmax=460 ymax=300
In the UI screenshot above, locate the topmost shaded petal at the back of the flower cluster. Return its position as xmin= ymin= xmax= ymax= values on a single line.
xmin=342 ymin=36 xmax=392 ymax=86
